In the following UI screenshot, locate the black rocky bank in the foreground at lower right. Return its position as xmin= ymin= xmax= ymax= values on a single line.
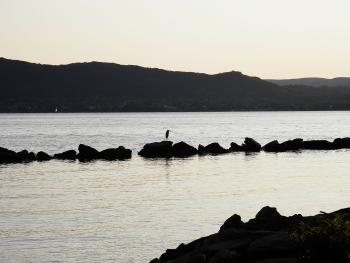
xmin=150 ymin=206 xmax=350 ymax=263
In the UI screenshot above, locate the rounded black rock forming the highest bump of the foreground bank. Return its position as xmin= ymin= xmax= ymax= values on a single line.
xmin=245 ymin=206 xmax=287 ymax=231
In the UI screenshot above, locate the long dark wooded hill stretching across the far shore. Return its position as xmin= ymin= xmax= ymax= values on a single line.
xmin=0 ymin=58 xmax=350 ymax=112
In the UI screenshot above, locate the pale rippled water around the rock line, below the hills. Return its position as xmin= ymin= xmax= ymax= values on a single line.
xmin=0 ymin=112 xmax=350 ymax=263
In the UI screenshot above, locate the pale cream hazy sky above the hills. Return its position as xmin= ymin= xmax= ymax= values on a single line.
xmin=0 ymin=0 xmax=350 ymax=78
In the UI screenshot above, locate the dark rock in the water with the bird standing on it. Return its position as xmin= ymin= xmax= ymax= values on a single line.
xmin=138 ymin=141 xmax=173 ymax=158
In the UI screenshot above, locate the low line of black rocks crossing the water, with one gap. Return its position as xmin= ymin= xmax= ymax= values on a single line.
xmin=0 ymin=137 xmax=350 ymax=163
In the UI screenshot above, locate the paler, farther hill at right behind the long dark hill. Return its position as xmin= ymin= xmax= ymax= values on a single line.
xmin=266 ymin=78 xmax=350 ymax=87
